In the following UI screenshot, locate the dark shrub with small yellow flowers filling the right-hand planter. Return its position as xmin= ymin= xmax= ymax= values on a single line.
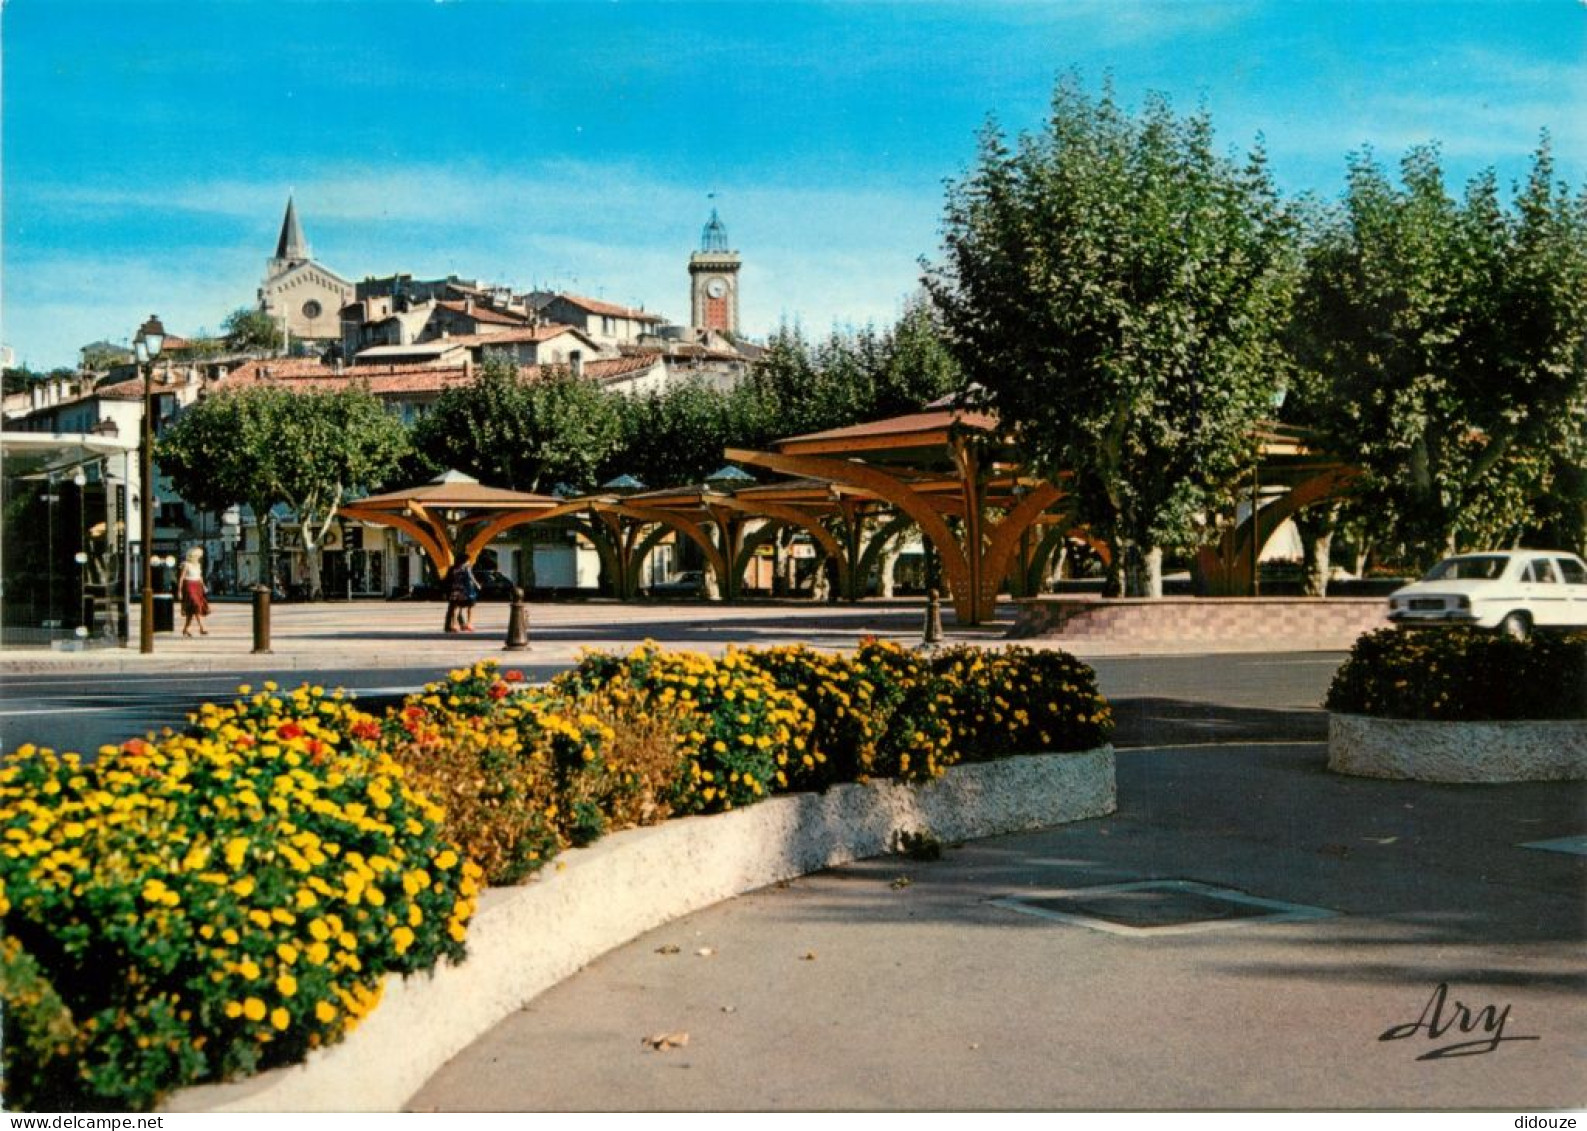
xmin=1327 ymin=628 xmax=1587 ymax=720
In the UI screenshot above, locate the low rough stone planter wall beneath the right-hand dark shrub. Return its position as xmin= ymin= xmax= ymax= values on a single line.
xmin=1328 ymin=714 xmax=1587 ymax=782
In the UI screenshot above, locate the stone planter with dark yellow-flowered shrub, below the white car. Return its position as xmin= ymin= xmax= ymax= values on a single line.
xmin=1327 ymin=630 xmax=1587 ymax=782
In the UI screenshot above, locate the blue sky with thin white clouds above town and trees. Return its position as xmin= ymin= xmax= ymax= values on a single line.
xmin=0 ymin=0 xmax=1587 ymax=368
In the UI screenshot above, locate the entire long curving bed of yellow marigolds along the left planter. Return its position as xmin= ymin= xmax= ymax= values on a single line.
xmin=0 ymin=642 xmax=1111 ymax=1110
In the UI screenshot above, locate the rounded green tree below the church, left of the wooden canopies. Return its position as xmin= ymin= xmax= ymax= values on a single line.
xmin=156 ymin=385 xmax=408 ymax=598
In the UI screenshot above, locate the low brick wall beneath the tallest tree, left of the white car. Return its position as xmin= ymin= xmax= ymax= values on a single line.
xmin=1009 ymin=596 xmax=1389 ymax=652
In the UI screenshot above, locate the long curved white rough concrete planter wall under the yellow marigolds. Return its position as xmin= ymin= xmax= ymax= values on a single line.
xmin=163 ymin=746 xmax=1117 ymax=1112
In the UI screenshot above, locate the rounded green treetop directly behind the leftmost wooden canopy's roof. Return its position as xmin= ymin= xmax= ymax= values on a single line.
xmin=414 ymin=362 xmax=622 ymax=492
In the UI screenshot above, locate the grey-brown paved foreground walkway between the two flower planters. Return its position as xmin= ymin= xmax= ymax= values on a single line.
xmin=413 ymin=744 xmax=1587 ymax=1112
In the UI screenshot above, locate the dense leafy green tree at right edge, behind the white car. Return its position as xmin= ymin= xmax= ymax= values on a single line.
xmin=1287 ymin=136 xmax=1587 ymax=566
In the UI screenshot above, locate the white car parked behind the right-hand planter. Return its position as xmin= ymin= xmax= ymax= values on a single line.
xmin=1389 ymin=550 xmax=1587 ymax=639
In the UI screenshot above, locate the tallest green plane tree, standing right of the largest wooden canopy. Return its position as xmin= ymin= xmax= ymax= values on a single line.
xmin=925 ymin=76 xmax=1295 ymax=595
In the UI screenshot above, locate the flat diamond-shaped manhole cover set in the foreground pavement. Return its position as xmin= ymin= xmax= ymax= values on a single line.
xmin=995 ymin=880 xmax=1336 ymax=934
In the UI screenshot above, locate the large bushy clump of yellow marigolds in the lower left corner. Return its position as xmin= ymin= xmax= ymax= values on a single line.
xmin=0 ymin=685 xmax=478 ymax=1110
